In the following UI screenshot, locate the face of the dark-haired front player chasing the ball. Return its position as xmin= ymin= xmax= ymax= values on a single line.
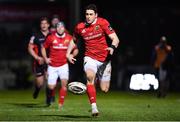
xmin=86 ymin=10 xmax=97 ymax=24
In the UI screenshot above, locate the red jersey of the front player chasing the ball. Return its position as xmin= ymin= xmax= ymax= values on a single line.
xmin=74 ymin=17 xmax=114 ymax=61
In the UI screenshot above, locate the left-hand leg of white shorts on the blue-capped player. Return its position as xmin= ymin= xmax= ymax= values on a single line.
xmin=47 ymin=66 xmax=58 ymax=85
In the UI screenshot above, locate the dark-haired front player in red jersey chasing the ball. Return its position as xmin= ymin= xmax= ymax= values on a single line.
xmin=66 ymin=4 xmax=119 ymax=116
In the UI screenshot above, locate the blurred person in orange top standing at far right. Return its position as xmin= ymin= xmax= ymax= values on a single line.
xmin=152 ymin=36 xmax=173 ymax=97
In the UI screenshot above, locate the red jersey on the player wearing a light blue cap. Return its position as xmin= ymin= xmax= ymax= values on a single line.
xmin=43 ymin=33 xmax=72 ymax=67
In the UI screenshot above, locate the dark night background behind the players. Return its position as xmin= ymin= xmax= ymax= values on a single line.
xmin=0 ymin=0 xmax=180 ymax=90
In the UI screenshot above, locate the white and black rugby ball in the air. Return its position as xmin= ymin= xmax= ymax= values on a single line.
xmin=68 ymin=82 xmax=87 ymax=94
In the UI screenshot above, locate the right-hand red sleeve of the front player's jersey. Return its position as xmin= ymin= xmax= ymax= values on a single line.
xmin=100 ymin=19 xmax=115 ymax=35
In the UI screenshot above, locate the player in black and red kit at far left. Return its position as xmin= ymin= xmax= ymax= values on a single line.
xmin=28 ymin=17 xmax=50 ymax=99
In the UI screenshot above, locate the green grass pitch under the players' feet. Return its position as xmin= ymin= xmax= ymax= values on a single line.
xmin=0 ymin=90 xmax=180 ymax=121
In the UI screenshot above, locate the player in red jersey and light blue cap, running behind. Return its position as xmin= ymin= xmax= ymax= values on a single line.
xmin=42 ymin=22 xmax=78 ymax=108
